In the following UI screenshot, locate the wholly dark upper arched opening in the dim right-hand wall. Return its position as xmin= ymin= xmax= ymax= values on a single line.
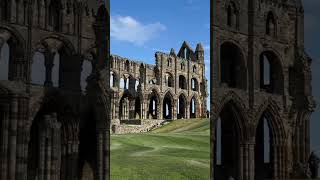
xmin=220 ymin=42 xmax=247 ymax=89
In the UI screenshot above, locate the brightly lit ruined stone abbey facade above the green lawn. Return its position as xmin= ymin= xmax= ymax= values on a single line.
xmin=110 ymin=42 xmax=208 ymax=124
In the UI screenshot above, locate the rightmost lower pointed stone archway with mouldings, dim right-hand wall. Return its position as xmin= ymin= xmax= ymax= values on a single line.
xmin=254 ymin=101 xmax=287 ymax=179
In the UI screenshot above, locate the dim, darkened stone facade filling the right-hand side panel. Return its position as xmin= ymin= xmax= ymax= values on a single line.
xmin=210 ymin=0 xmax=315 ymax=180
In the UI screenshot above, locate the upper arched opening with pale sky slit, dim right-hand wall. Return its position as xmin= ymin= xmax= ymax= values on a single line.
xmin=260 ymin=52 xmax=283 ymax=94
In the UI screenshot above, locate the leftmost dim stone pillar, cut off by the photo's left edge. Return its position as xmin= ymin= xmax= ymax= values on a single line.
xmin=0 ymin=104 xmax=9 ymax=179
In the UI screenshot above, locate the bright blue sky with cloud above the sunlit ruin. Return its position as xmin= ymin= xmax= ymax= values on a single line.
xmin=110 ymin=0 xmax=210 ymax=70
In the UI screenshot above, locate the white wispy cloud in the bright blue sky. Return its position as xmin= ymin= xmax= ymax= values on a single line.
xmin=110 ymin=16 xmax=166 ymax=45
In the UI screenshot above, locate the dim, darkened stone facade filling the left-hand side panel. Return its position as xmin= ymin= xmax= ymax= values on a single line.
xmin=0 ymin=0 xmax=111 ymax=180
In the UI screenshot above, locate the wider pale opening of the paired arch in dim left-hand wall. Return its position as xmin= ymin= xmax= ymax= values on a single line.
xmin=31 ymin=52 xmax=46 ymax=85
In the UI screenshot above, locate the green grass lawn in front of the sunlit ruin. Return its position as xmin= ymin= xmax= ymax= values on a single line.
xmin=111 ymin=119 xmax=210 ymax=180
